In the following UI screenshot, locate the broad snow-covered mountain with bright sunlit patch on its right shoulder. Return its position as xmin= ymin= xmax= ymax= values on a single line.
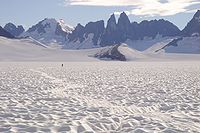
xmin=20 ymin=18 xmax=73 ymax=46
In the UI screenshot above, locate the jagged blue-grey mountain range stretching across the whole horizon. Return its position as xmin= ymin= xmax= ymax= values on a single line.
xmin=0 ymin=10 xmax=200 ymax=49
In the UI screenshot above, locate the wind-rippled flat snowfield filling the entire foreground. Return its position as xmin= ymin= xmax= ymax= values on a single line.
xmin=0 ymin=62 xmax=200 ymax=133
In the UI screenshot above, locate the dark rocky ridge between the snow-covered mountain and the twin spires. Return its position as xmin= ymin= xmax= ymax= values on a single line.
xmin=68 ymin=20 xmax=104 ymax=45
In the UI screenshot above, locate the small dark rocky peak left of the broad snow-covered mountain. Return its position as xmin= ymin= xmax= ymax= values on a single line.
xmin=4 ymin=23 xmax=24 ymax=37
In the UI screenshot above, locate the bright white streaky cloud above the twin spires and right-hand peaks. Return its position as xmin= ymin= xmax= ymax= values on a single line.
xmin=65 ymin=0 xmax=200 ymax=16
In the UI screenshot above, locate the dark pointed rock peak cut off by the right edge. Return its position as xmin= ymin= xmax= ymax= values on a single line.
xmin=182 ymin=10 xmax=200 ymax=36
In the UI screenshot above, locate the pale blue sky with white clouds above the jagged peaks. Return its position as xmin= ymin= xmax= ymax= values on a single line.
xmin=0 ymin=0 xmax=200 ymax=29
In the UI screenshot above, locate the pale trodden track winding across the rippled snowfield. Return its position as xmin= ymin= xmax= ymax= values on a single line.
xmin=30 ymin=69 xmax=160 ymax=115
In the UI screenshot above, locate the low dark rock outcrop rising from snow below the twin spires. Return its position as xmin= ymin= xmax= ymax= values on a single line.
xmin=95 ymin=45 xmax=126 ymax=61
